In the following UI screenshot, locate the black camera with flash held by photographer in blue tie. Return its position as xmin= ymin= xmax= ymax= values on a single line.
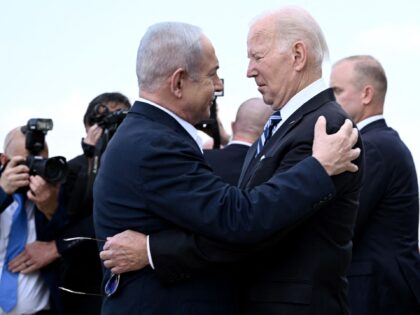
xmin=21 ymin=118 xmax=68 ymax=184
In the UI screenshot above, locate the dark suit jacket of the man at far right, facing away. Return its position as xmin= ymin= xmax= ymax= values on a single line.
xmin=348 ymin=119 xmax=420 ymax=315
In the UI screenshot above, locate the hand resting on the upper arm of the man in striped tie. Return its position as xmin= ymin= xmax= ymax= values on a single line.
xmin=312 ymin=116 xmax=360 ymax=176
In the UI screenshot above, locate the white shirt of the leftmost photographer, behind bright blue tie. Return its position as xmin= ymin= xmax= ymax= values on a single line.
xmin=0 ymin=200 xmax=50 ymax=315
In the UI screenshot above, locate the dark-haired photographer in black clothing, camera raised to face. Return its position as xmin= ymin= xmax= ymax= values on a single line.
xmin=58 ymin=93 xmax=131 ymax=315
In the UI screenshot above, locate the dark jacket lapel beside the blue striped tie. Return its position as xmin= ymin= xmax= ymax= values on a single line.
xmin=239 ymin=89 xmax=335 ymax=187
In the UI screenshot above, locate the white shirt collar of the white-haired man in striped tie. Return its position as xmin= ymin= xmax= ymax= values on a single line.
xmin=274 ymin=78 xmax=327 ymax=132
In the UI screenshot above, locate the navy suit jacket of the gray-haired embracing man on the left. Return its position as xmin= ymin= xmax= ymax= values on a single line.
xmin=94 ymin=102 xmax=335 ymax=315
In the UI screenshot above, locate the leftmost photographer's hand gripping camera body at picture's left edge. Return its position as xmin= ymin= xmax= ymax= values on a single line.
xmin=0 ymin=155 xmax=29 ymax=195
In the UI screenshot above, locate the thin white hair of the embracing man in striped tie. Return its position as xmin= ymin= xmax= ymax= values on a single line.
xmin=254 ymin=6 xmax=329 ymax=67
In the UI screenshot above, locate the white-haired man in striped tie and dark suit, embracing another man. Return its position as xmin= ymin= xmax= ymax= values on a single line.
xmin=101 ymin=7 xmax=362 ymax=314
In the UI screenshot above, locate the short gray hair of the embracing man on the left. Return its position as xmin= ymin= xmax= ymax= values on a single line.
xmin=136 ymin=22 xmax=203 ymax=92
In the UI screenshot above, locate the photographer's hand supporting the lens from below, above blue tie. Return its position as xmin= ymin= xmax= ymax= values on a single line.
xmin=27 ymin=175 xmax=60 ymax=220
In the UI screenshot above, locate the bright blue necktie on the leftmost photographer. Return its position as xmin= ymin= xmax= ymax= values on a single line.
xmin=0 ymin=194 xmax=28 ymax=313
